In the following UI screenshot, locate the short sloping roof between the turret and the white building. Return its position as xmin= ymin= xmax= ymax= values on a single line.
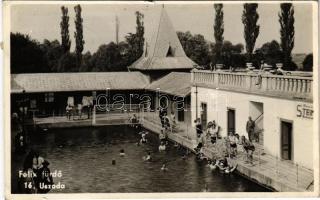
xmin=146 ymin=72 xmax=191 ymax=97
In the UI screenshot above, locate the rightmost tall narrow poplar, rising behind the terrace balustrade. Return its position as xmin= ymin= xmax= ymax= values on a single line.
xmin=279 ymin=3 xmax=296 ymax=70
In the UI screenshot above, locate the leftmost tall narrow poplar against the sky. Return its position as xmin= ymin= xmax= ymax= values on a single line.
xmin=60 ymin=6 xmax=71 ymax=53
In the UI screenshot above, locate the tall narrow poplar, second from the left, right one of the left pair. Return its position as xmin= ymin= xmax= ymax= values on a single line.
xmin=74 ymin=5 xmax=84 ymax=67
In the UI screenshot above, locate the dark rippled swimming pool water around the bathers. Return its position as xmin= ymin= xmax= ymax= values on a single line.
xmin=12 ymin=126 xmax=268 ymax=193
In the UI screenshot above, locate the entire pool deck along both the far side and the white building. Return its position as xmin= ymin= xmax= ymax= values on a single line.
xmin=28 ymin=113 xmax=314 ymax=192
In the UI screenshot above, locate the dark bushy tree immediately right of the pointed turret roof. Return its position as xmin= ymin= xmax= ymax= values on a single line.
xmin=177 ymin=31 xmax=210 ymax=68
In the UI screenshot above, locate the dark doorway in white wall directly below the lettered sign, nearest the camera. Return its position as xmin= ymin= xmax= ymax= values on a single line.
xmin=281 ymin=121 xmax=293 ymax=160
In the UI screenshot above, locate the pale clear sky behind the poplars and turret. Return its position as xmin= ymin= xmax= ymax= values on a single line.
xmin=11 ymin=2 xmax=313 ymax=53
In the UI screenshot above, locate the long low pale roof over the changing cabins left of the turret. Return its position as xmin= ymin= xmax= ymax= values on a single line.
xmin=11 ymin=72 xmax=149 ymax=93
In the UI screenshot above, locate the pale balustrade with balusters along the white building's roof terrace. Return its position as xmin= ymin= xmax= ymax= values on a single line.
xmin=192 ymin=70 xmax=313 ymax=101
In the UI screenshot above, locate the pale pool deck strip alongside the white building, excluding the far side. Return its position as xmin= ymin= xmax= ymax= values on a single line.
xmin=142 ymin=112 xmax=314 ymax=192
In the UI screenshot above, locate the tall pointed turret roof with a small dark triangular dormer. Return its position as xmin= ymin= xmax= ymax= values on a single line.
xmin=129 ymin=7 xmax=196 ymax=70
